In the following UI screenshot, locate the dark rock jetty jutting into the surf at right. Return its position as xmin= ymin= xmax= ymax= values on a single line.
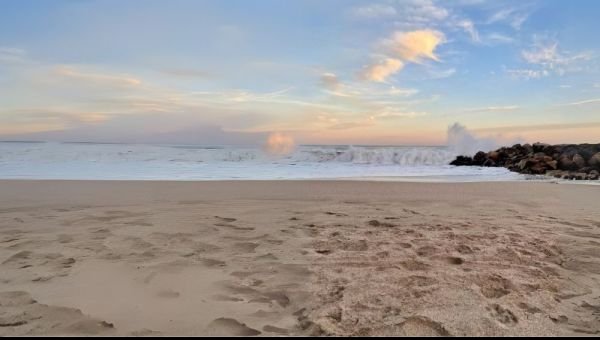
xmin=450 ymin=143 xmax=600 ymax=180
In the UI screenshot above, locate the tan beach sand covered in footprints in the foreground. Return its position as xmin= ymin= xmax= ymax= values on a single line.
xmin=0 ymin=181 xmax=600 ymax=336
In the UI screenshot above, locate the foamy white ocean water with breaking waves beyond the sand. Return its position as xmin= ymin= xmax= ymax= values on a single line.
xmin=0 ymin=142 xmax=527 ymax=182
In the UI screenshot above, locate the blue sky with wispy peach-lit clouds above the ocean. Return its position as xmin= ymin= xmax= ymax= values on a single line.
xmin=0 ymin=0 xmax=600 ymax=145
